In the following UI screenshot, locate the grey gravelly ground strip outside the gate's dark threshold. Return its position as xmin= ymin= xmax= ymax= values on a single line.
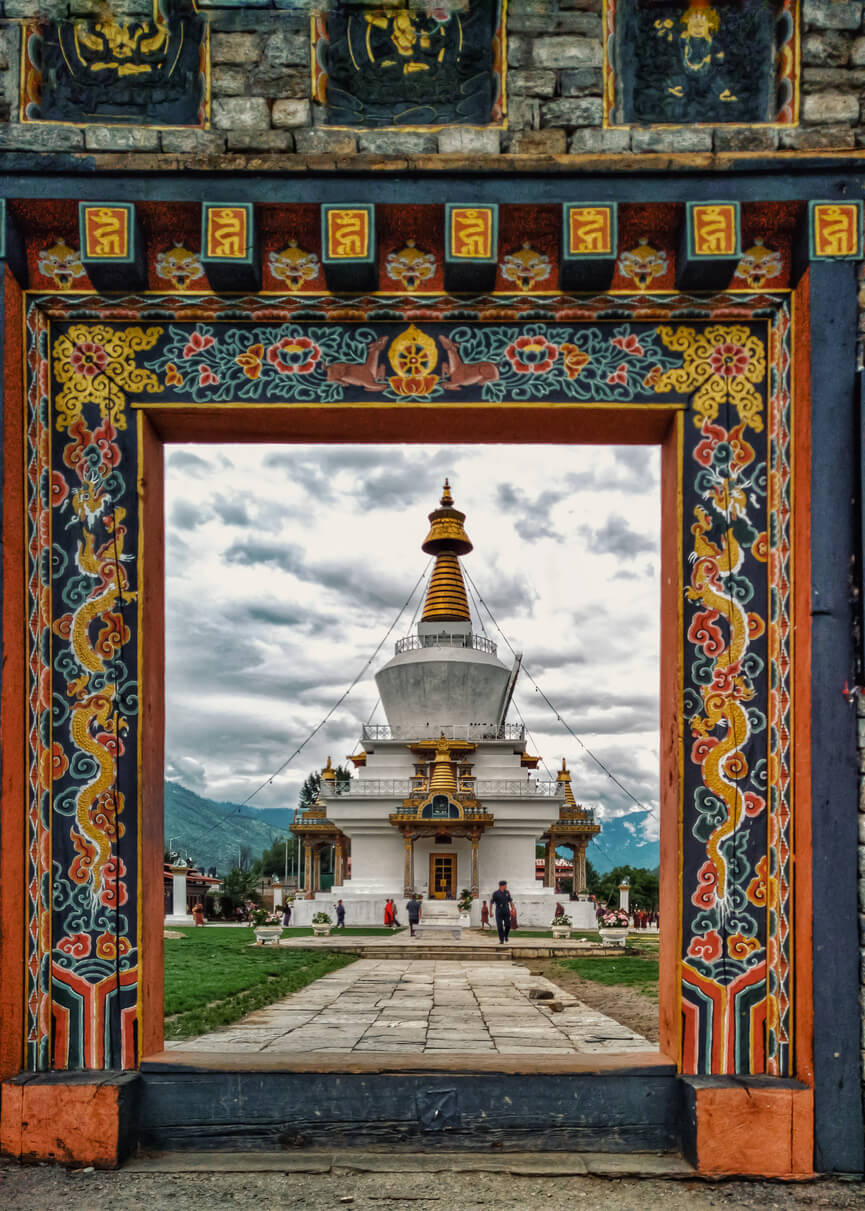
xmin=0 ymin=1155 xmax=865 ymax=1211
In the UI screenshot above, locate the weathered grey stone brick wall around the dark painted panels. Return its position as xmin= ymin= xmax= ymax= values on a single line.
xmin=0 ymin=0 xmax=865 ymax=168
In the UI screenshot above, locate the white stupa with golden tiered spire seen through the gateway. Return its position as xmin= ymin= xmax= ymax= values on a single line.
xmin=294 ymin=481 xmax=600 ymax=929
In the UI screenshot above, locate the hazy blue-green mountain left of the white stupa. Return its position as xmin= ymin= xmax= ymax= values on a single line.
xmin=165 ymin=782 xmax=294 ymax=874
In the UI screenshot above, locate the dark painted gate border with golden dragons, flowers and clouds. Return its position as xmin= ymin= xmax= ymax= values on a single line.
xmin=21 ymin=295 xmax=792 ymax=1075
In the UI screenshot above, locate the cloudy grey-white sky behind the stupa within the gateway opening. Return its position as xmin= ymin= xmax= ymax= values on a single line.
xmin=166 ymin=446 xmax=660 ymax=836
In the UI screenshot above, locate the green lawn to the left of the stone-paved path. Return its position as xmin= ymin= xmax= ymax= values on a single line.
xmin=165 ymin=925 xmax=353 ymax=1039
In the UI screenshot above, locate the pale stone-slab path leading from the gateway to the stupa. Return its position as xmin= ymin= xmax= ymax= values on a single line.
xmin=166 ymin=959 xmax=657 ymax=1055
